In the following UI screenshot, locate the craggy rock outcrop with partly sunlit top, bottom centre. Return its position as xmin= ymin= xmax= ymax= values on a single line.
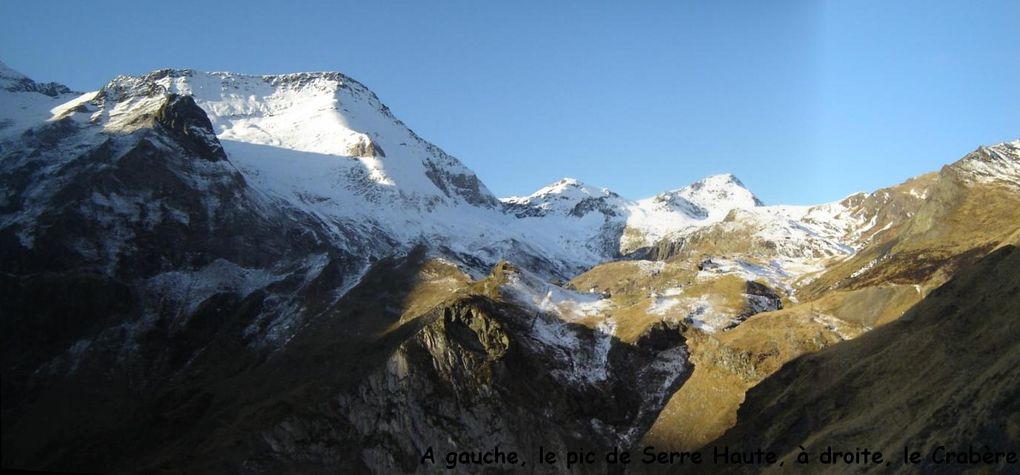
xmin=267 ymin=298 xmax=690 ymax=473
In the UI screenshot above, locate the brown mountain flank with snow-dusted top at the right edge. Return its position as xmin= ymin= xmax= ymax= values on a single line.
xmin=805 ymin=141 xmax=1020 ymax=305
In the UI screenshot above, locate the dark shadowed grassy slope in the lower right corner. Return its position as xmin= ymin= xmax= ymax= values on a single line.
xmin=712 ymin=246 xmax=1020 ymax=473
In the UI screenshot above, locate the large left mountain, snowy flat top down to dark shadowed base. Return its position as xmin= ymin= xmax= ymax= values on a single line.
xmin=0 ymin=63 xmax=689 ymax=472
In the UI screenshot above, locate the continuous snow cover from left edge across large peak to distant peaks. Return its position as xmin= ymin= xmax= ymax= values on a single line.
xmin=0 ymin=60 xmax=946 ymax=276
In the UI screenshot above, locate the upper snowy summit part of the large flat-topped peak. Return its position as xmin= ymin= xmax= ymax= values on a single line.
xmin=93 ymin=69 xmax=499 ymax=210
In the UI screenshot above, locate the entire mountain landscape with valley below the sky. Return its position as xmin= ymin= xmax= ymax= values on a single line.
xmin=0 ymin=64 xmax=1020 ymax=473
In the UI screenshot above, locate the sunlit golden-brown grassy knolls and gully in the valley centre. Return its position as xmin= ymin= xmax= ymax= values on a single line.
xmin=571 ymin=258 xmax=864 ymax=450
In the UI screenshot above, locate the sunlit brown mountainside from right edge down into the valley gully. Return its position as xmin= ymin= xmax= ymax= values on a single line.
xmin=628 ymin=142 xmax=1020 ymax=450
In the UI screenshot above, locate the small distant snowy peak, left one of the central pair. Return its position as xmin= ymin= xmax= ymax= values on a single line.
xmin=503 ymin=178 xmax=627 ymax=218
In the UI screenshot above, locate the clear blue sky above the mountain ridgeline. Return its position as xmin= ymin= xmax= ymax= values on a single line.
xmin=0 ymin=0 xmax=1020 ymax=204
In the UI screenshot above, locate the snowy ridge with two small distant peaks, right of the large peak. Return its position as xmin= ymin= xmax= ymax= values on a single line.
xmin=503 ymin=169 xmax=860 ymax=271
